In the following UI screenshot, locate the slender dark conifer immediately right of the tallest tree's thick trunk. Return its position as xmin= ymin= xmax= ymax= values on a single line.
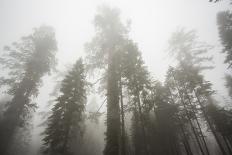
xmin=122 ymin=40 xmax=151 ymax=155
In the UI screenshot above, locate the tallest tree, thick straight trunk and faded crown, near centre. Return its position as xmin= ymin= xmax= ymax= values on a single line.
xmin=86 ymin=6 xmax=127 ymax=155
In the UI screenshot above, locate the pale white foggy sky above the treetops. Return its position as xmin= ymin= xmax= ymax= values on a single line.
xmin=0 ymin=0 xmax=231 ymax=103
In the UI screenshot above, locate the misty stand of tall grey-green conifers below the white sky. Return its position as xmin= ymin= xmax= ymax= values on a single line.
xmin=0 ymin=0 xmax=232 ymax=155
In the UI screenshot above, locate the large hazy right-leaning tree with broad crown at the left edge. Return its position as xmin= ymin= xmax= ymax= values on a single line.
xmin=0 ymin=26 xmax=57 ymax=155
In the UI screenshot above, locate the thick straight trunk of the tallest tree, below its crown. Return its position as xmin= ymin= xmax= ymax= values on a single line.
xmin=104 ymin=53 xmax=120 ymax=155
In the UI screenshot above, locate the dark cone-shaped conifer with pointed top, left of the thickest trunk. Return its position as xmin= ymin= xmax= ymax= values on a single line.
xmin=43 ymin=59 xmax=86 ymax=155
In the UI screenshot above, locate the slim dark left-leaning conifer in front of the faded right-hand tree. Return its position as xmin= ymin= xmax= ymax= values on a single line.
xmin=168 ymin=66 xmax=213 ymax=154
